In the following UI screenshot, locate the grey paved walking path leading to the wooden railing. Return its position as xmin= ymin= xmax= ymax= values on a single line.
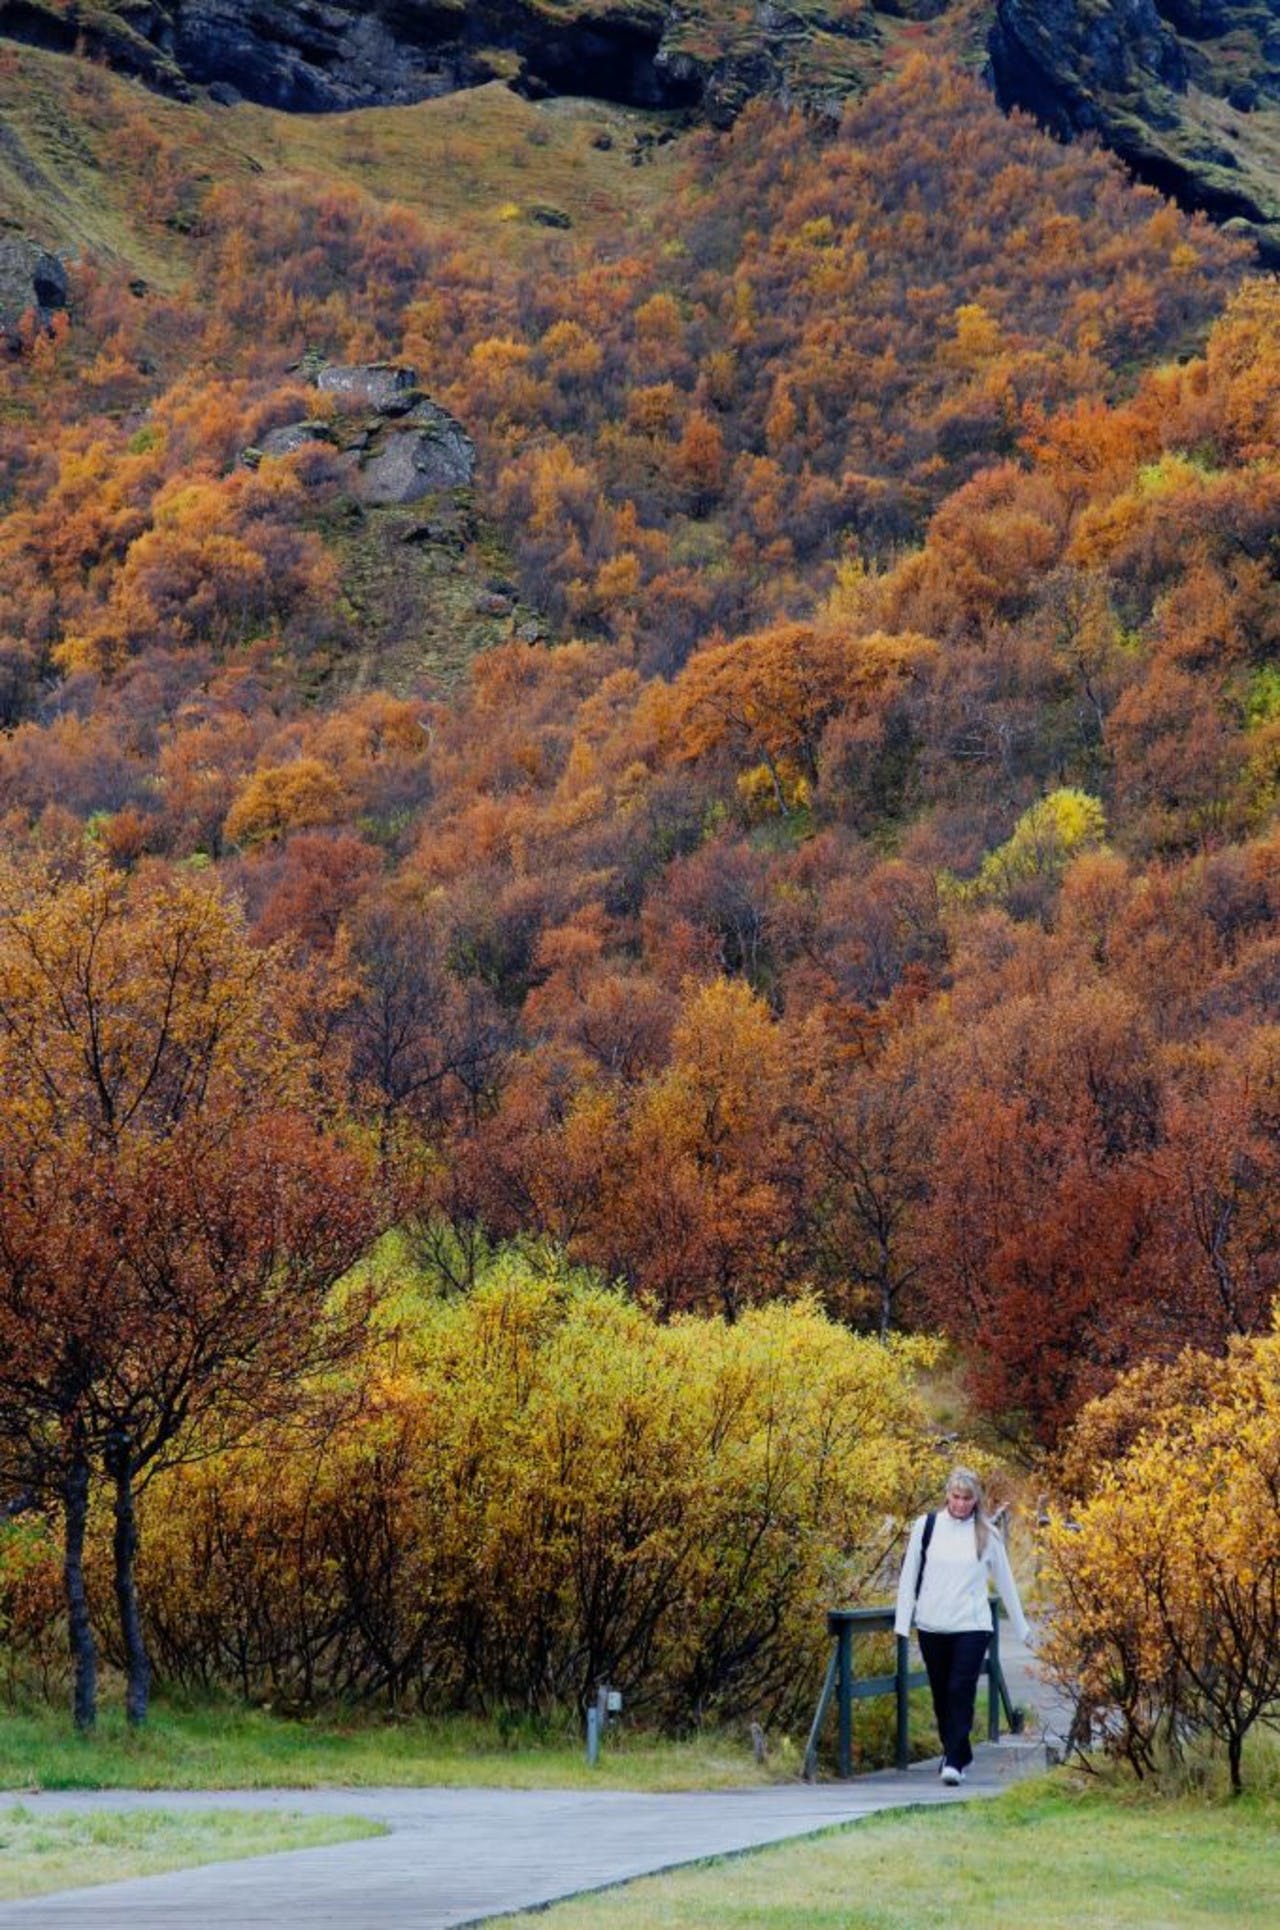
xmin=0 ymin=1650 xmax=1044 ymax=1930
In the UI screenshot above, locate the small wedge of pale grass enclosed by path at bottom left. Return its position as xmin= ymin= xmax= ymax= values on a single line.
xmin=0 ymin=1805 xmax=386 ymax=1903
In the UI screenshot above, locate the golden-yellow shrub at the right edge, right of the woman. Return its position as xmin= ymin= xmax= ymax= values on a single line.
xmin=1046 ymin=1334 xmax=1280 ymax=1793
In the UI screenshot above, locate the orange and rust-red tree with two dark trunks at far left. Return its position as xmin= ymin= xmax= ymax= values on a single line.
xmin=0 ymin=861 xmax=386 ymax=1727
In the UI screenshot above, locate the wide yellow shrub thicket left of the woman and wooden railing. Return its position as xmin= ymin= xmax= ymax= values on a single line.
xmin=141 ymin=1260 xmax=938 ymax=1725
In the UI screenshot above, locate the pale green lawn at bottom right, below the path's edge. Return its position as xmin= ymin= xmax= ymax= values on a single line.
xmin=488 ymin=1776 xmax=1280 ymax=1930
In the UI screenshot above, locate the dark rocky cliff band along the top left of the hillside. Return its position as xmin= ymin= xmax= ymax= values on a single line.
xmin=0 ymin=0 xmax=877 ymax=122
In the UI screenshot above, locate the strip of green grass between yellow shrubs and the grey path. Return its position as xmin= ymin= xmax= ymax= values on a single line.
xmin=0 ymin=1704 xmax=779 ymax=1789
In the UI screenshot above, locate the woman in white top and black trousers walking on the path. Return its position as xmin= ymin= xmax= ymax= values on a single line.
xmin=894 ymin=1467 xmax=1029 ymax=1783
